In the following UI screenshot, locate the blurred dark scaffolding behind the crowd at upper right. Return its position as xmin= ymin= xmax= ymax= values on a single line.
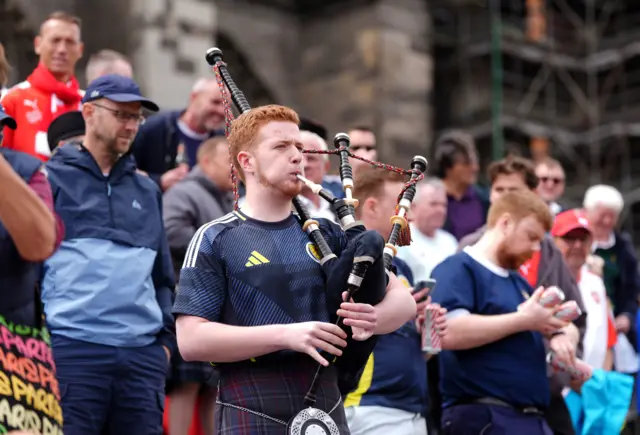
xmin=430 ymin=0 xmax=640 ymax=245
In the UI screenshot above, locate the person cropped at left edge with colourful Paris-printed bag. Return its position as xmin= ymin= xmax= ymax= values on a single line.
xmin=0 ymin=106 xmax=64 ymax=435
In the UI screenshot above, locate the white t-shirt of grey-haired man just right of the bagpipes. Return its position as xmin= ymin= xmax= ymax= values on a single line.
xmin=398 ymin=224 xmax=458 ymax=282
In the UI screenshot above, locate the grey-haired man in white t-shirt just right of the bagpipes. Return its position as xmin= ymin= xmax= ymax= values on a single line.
xmin=398 ymin=178 xmax=458 ymax=282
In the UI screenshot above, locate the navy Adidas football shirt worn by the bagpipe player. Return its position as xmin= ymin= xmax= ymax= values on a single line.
xmin=173 ymin=212 xmax=347 ymax=362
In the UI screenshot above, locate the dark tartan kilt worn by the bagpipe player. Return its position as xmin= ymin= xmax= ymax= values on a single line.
xmin=215 ymin=355 xmax=350 ymax=435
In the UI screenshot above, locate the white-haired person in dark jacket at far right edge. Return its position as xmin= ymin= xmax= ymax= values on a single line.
xmin=583 ymin=184 xmax=640 ymax=371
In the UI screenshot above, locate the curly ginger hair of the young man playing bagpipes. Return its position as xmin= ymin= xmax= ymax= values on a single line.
xmin=229 ymin=104 xmax=300 ymax=181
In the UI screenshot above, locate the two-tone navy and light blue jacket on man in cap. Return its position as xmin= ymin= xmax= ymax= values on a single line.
xmin=42 ymin=143 xmax=175 ymax=349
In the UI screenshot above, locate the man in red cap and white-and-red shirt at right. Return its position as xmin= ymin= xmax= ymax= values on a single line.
xmin=551 ymin=209 xmax=616 ymax=370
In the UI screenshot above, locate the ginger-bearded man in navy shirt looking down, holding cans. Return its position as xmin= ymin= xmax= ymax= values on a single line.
xmin=432 ymin=190 xmax=579 ymax=435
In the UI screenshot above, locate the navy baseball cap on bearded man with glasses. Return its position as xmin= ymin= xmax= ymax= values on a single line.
xmin=82 ymin=74 xmax=160 ymax=112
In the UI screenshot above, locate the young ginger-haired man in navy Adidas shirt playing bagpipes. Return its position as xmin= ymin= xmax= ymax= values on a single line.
xmin=174 ymin=105 xmax=416 ymax=435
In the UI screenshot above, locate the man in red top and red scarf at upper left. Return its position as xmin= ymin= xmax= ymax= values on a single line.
xmin=2 ymin=12 xmax=84 ymax=161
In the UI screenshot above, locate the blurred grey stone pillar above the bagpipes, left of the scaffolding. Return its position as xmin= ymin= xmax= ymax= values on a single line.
xmin=298 ymin=0 xmax=433 ymax=167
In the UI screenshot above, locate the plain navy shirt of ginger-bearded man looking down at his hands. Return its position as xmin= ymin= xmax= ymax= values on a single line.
xmin=431 ymin=247 xmax=550 ymax=408
